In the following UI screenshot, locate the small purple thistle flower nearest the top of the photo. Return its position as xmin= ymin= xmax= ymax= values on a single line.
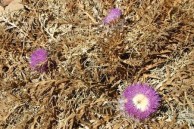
xmin=104 ymin=8 xmax=122 ymax=24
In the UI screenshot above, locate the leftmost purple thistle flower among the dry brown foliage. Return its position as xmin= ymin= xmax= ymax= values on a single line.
xmin=30 ymin=48 xmax=48 ymax=72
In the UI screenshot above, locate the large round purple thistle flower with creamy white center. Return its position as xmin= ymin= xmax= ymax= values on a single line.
xmin=123 ymin=83 xmax=160 ymax=120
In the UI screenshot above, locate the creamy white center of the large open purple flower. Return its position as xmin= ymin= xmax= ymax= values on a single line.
xmin=133 ymin=94 xmax=149 ymax=112
